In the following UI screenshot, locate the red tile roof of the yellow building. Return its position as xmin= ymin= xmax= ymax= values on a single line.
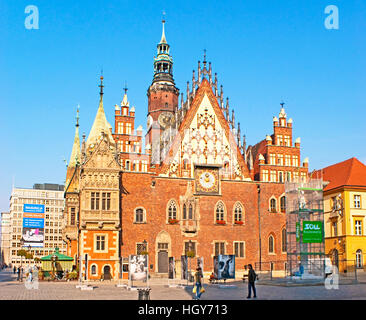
xmin=311 ymin=158 xmax=366 ymax=191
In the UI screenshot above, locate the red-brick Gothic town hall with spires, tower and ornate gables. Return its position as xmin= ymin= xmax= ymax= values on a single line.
xmin=64 ymin=22 xmax=308 ymax=279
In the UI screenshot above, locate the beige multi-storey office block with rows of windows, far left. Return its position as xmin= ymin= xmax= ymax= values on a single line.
xmin=10 ymin=183 xmax=66 ymax=266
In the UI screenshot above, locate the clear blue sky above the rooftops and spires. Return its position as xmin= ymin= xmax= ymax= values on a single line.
xmin=0 ymin=0 xmax=366 ymax=211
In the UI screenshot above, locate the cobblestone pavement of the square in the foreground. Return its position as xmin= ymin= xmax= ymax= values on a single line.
xmin=0 ymin=269 xmax=366 ymax=300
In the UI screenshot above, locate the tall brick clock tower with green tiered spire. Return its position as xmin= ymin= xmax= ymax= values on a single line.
xmin=145 ymin=20 xmax=179 ymax=164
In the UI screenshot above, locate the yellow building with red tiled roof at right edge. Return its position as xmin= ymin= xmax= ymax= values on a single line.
xmin=312 ymin=158 xmax=366 ymax=272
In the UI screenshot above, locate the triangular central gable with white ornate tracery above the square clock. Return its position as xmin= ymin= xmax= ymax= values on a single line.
xmin=159 ymin=79 xmax=250 ymax=180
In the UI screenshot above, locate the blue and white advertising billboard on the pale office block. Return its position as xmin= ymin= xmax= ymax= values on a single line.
xmin=22 ymin=204 xmax=45 ymax=247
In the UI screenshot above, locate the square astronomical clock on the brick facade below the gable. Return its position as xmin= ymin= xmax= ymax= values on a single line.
xmin=195 ymin=167 xmax=219 ymax=194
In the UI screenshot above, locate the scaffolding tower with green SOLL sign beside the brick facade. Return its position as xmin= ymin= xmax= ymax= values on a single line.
xmin=285 ymin=179 xmax=325 ymax=279
